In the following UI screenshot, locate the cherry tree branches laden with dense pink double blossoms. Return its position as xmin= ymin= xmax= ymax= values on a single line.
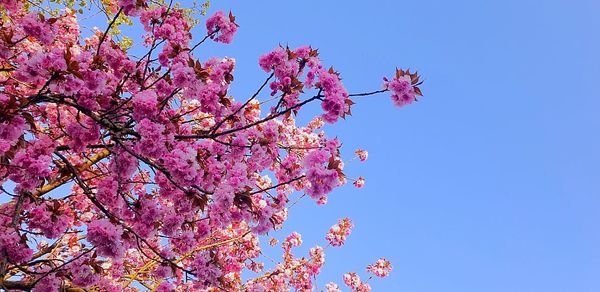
xmin=0 ymin=0 xmax=421 ymax=291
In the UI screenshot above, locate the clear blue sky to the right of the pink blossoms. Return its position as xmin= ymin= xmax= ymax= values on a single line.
xmin=199 ymin=0 xmax=600 ymax=292
